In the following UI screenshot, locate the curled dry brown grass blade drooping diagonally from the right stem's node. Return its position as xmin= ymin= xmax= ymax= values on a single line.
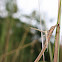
xmin=34 ymin=24 xmax=57 ymax=62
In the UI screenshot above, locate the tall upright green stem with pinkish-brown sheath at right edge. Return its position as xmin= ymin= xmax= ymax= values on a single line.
xmin=54 ymin=0 xmax=61 ymax=62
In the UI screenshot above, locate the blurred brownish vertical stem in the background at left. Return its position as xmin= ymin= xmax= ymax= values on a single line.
xmin=5 ymin=20 xmax=11 ymax=62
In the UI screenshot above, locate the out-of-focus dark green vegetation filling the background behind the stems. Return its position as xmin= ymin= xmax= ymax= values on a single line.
xmin=0 ymin=0 xmax=62 ymax=62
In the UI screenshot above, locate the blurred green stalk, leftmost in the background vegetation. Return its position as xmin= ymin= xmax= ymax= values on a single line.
xmin=0 ymin=20 xmax=7 ymax=62
